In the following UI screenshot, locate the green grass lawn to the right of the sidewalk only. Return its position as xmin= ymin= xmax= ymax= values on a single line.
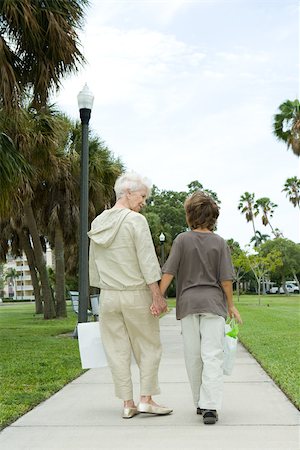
xmin=169 ymin=295 xmax=300 ymax=409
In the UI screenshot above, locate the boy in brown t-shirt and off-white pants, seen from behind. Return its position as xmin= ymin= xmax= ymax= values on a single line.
xmin=160 ymin=191 xmax=242 ymax=424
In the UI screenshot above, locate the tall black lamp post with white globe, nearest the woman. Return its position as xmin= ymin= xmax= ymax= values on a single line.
xmin=77 ymin=84 xmax=94 ymax=323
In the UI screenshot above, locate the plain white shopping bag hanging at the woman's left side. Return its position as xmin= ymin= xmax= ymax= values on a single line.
xmin=77 ymin=322 xmax=108 ymax=369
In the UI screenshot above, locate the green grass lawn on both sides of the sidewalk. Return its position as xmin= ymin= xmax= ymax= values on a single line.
xmin=0 ymin=295 xmax=300 ymax=428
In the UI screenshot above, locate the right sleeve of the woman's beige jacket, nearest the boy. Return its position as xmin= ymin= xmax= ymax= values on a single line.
xmin=133 ymin=214 xmax=161 ymax=284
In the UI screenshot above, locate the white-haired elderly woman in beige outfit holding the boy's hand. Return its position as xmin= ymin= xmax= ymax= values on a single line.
xmin=88 ymin=172 xmax=172 ymax=419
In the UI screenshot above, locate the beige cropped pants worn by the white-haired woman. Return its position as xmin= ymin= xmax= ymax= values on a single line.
xmin=100 ymin=289 xmax=161 ymax=400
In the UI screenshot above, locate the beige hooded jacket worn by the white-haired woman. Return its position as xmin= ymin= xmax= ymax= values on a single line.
xmin=88 ymin=208 xmax=161 ymax=290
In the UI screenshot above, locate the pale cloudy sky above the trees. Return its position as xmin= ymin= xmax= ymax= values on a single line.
xmin=54 ymin=0 xmax=300 ymax=247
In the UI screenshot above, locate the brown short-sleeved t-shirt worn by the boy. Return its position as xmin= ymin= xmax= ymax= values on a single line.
xmin=162 ymin=231 xmax=233 ymax=319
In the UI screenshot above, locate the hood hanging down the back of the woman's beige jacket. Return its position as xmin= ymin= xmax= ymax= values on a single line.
xmin=88 ymin=208 xmax=131 ymax=247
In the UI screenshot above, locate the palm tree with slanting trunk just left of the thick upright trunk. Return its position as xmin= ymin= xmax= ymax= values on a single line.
xmin=0 ymin=107 xmax=70 ymax=319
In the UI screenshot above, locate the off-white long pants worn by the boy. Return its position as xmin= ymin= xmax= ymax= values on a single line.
xmin=181 ymin=314 xmax=225 ymax=410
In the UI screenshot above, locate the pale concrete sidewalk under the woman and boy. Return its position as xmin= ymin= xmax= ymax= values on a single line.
xmin=0 ymin=311 xmax=300 ymax=450
